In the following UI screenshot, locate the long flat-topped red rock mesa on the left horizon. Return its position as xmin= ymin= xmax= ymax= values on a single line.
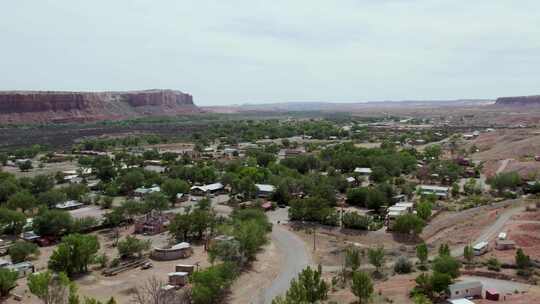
xmin=0 ymin=90 xmax=200 ymax=124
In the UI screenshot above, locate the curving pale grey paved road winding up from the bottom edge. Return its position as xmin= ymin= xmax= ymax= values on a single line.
xmin=260 ymin=208 xmax=312 ymax=304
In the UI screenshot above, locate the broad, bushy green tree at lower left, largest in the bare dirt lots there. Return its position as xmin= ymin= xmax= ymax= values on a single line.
xmin=49 ymin=234 xmax=99 ymax=277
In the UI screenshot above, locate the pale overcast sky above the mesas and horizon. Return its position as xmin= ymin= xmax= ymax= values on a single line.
xmin=0 ymin=0 xmax=540 ymax=105
